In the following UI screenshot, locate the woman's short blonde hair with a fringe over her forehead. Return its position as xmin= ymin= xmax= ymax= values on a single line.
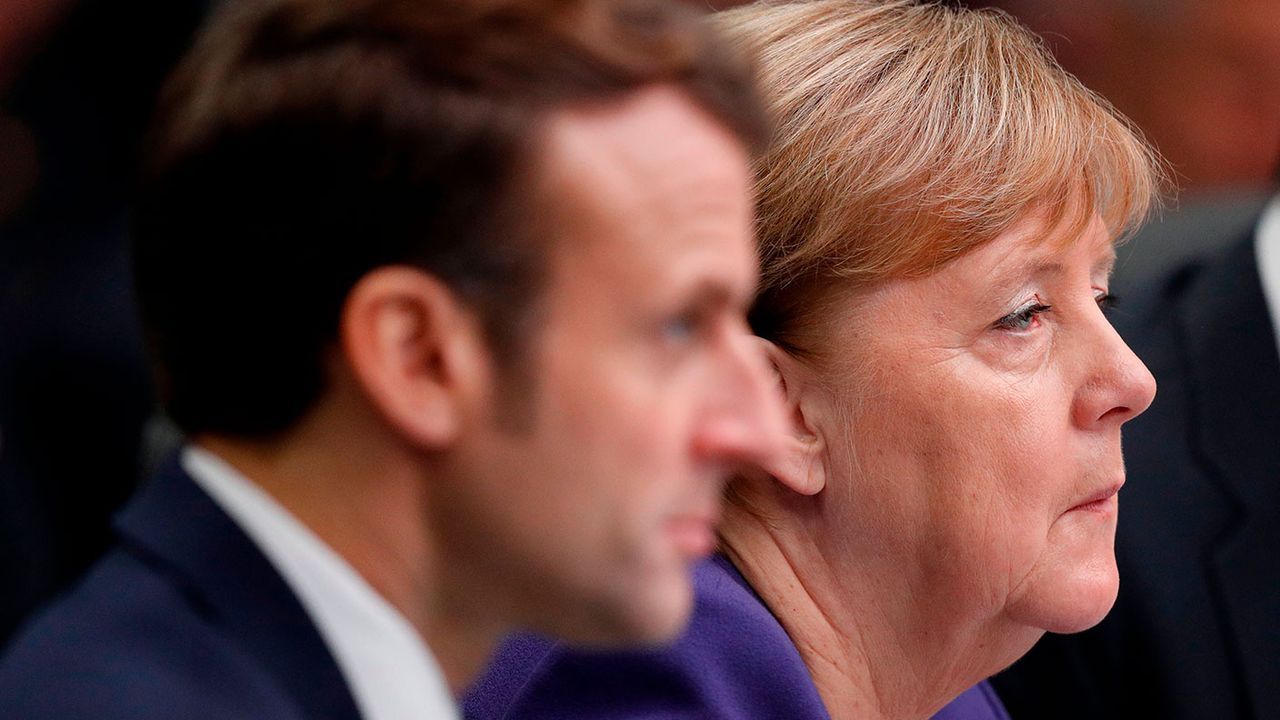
xmin=713 ymin=0 xmax=1165 ymax=342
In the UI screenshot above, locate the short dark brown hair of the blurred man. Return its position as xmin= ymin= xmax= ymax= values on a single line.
xmin=134 ymin=0 xmax=763 ymax=436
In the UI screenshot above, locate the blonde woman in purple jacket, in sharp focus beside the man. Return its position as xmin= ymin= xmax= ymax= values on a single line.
xmin=467 ymin=0 xmax=1160 ymax=720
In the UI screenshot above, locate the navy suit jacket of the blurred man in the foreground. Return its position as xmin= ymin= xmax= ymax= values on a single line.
xmin=0 ymin=462 xmax=360 ymax=720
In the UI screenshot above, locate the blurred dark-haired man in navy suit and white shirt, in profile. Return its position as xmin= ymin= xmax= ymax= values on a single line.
xmin=0 ymin=0 xmax=782 ymax=720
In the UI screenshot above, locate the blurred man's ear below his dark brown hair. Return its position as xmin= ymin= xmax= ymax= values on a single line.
xmin=339 ymin=265 xmax=490 ymax=448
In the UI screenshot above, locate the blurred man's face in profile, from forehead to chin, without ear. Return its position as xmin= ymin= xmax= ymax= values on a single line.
xmin=437 ymin=88 xmax=782 ymax=644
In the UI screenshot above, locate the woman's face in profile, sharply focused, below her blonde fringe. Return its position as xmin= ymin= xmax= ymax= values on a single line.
xmin=819 ymin=210 xmax=1156 ymax=632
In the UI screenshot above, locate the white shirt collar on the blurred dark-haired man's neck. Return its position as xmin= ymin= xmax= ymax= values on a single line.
xmin=182 ymin=446 xmax=458 ymax=720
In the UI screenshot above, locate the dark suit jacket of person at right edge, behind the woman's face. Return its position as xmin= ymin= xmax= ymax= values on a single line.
xmin=996 ymin=230 xmax=1280 ymax=720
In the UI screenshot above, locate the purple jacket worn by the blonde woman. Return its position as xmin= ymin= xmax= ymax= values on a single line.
xmin=463 ymin=556 xmax=1007 ymax=720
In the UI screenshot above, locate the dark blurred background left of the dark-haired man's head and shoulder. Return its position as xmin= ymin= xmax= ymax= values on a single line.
xmin=0 ymin=0 xmax=212 ymax=639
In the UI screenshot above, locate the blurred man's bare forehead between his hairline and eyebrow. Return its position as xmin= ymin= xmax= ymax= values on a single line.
xmin=529 ymin=87 xmax=755 ymax=292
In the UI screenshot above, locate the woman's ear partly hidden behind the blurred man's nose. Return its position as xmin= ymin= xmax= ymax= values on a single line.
xmin=756 ymin=338 xmax=827 ymax=495
